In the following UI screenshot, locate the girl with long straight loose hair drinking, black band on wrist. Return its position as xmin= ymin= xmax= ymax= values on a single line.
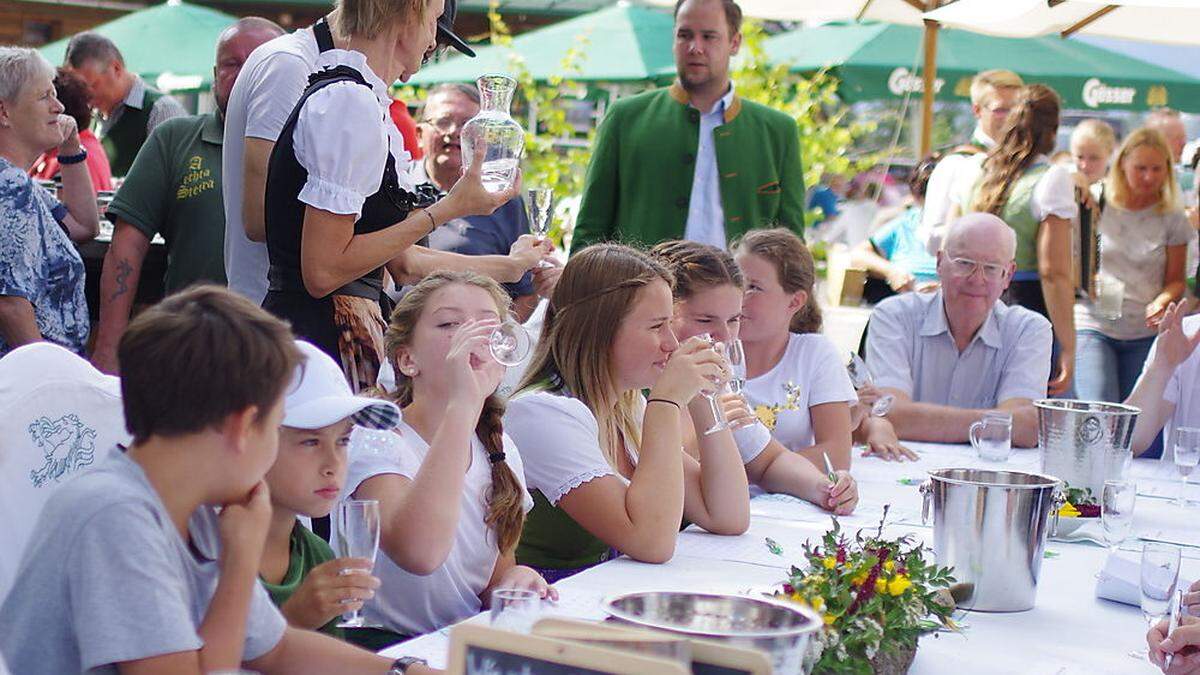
xmin=504 ymin=244 xmax=750 ymax=580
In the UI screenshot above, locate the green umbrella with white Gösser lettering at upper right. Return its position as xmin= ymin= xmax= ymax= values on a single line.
xmin=767 ymin=23 xmax=1200 ymax=112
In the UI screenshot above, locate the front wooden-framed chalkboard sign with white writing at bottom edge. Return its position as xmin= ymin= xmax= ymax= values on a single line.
xmin=449 ymin=623 xmax=688 ymax=675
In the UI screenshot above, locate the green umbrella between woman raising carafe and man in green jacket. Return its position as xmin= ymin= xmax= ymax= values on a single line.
xmin=409 ymin=4 xmax=674 ymax=85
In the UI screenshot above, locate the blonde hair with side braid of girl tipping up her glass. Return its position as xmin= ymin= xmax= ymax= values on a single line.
xmin=384 ymin=271 xmax=524 ymax=554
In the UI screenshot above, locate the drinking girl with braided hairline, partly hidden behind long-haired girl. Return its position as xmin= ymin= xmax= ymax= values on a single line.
xmin=650 ymin=240 xmax=858 ymax=506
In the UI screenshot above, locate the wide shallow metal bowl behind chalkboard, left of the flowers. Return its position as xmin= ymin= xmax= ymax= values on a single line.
xmin=604 ymin=591 xmax=824 ymax=675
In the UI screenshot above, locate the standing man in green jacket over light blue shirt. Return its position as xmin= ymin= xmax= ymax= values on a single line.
xmin=572 ymin=0 xmax=804 ymax=251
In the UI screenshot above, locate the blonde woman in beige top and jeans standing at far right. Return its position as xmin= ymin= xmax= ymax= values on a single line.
xmin=1075 ymin=129 xmax=1195 ymax=402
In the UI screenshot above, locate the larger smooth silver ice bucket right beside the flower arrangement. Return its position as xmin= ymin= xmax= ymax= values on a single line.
xmin=920 ymin=468 xmax=1062 ymax=611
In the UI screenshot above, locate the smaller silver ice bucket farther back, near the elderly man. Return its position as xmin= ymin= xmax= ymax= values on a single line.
xmin=1033 ymin=399 xmax=1141 ymax=502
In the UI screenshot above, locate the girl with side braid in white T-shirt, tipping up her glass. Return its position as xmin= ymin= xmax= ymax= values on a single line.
xmin=347 ymin=273 xmax=553 ymax=646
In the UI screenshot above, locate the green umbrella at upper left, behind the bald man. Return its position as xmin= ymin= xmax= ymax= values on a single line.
xmin=41 ymin=1 xmax=238 ymax=91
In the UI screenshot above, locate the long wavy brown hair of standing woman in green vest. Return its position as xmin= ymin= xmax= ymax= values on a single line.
xmin=970 ymin=84 xmax=1061 ymax=215
